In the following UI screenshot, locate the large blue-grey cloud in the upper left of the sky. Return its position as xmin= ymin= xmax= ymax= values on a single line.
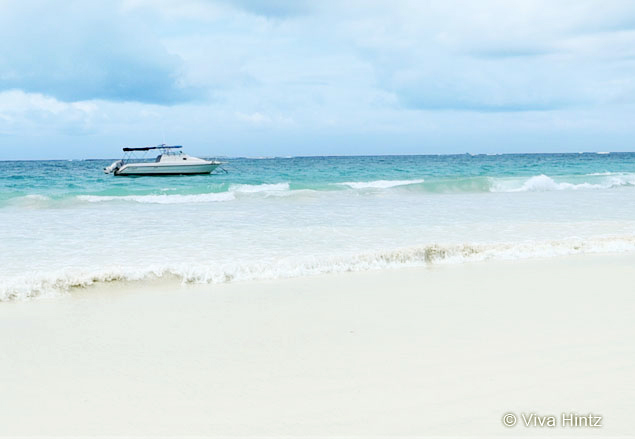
xmin=0 ymin=1 xmax=195 ymax=104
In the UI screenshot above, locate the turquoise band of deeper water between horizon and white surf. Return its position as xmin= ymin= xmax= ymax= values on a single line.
xmin=0 ymin=153 xmax=635 ymax=204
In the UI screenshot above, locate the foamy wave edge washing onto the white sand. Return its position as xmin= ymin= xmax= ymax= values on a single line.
xmin=0 ymin=236 xmax=635 ymax=302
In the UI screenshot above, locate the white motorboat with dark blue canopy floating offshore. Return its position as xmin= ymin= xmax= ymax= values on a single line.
xmin=104 ymin=144 xmax=221 ymax=175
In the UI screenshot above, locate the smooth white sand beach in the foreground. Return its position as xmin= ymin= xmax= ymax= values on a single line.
xmin=0 ymin=256 xmax=635 ymax=437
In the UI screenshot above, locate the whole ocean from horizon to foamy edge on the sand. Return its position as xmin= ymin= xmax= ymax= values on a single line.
xmin=0 ymin=153 xmax=635 ymax=301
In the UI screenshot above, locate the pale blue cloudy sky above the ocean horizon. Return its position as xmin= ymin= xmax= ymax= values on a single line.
xmin=0 ymin=0 xmax=635 ymax=160
